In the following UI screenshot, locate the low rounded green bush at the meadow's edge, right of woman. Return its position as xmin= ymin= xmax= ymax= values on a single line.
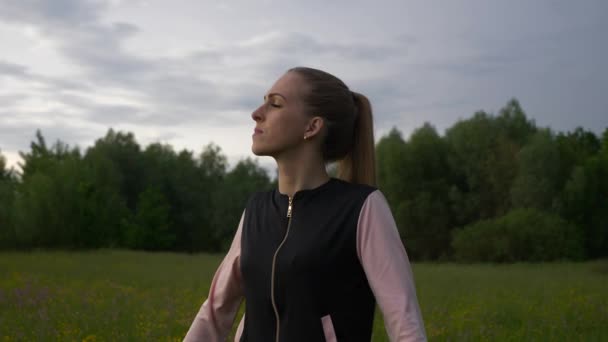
xmin=452 ymin=209 xmax=583 ymax=262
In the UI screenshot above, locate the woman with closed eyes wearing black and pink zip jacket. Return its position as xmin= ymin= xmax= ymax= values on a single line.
xmin=185 ymin=67 xmax=426 ymax=342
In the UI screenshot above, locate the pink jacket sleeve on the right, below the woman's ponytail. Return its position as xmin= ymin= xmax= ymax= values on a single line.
xmin=357 ymin=190 xmax=426 ymax=341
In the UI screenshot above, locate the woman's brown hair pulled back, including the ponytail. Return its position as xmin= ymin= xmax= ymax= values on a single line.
xmin=288 ymin=67 xmax=376 ymax=186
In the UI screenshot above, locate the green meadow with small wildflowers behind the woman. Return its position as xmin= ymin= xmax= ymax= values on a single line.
xmin=0 ymin=250 xmax=608 ymax=341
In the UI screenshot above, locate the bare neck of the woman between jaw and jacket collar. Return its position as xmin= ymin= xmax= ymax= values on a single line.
xmin=276 ymin=148 xmax=329 ymax=197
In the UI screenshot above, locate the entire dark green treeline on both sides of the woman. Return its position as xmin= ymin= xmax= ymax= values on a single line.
xmin=0 ymin=100 xmax=608 ymax=262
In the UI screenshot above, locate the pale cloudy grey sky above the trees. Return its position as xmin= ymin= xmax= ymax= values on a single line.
xmin=0 ymin=0 xmax=608 ymax=170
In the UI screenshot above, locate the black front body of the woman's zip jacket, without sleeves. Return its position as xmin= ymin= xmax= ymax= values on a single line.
xmin=240 ymin=178 xmax=376 ymax=342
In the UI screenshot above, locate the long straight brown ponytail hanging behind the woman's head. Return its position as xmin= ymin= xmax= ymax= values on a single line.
xmin=338 ymin=92 xmax=376 ymax=186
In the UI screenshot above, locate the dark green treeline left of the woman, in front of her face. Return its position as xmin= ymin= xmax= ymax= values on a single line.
xmin=0 ymin=129 xmax=272 ymax=252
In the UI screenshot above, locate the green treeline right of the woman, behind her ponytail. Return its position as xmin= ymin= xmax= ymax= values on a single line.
xmin=376 ymin=100 xmax=608 ymax=262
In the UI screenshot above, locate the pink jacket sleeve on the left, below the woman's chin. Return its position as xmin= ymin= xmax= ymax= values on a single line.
xmin=184 ymin=212 xmax=245 ymax=342
